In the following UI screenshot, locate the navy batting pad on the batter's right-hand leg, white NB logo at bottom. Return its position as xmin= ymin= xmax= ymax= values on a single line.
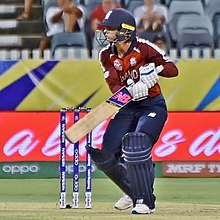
xmin=122 ymin=132 xmax=155 ymax=208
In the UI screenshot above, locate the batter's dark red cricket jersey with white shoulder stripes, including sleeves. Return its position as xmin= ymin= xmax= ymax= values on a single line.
xmin=99 ymin=38 xmax=178 ymax=97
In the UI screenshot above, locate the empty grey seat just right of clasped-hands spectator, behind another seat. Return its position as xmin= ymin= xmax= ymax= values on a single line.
xmin=168 ymin=0 xmax=204 ymax=42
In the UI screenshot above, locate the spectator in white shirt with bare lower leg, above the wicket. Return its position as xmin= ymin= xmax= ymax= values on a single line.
xmin=39 ymin=0 xmax=83 ymax=54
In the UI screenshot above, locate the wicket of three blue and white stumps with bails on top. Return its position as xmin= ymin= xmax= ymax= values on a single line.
xmin=60 ymin=107 xmax=92 ymax=209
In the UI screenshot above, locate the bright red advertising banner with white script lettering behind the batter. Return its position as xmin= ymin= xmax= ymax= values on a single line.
xmin=0 ymin=112 xmax=220 ymax=162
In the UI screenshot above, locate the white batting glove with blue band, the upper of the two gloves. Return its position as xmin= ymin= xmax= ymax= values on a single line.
xmin=139 ymin=63 xmax=163 ymax=89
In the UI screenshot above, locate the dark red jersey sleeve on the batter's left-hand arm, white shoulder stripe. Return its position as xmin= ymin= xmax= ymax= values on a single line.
xmin=99 ymin=51 xmax=122 ymax=93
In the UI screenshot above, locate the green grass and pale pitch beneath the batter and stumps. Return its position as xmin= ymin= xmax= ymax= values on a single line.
xmin=0 ymin=178 xmax=220 ymax=220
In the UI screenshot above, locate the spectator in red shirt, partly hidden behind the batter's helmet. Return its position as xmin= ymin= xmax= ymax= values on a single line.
xmin=91 ymin=0 xmax=121 ymax=33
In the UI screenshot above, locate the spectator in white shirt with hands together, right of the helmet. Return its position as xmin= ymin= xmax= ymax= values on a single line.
xmin=133 ymin=0 xmax=168 ymax=32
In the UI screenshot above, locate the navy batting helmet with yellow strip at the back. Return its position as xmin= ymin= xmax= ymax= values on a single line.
xmin=100 ymin=8 xmax=136 ymax=41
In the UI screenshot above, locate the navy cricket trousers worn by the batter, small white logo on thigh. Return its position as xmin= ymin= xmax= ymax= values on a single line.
xmin=102 ymin=94 xmax=167 ymax=157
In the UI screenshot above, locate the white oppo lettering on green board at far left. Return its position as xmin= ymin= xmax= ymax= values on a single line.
xmin=2 ymin=165 xmax=39 ymax=174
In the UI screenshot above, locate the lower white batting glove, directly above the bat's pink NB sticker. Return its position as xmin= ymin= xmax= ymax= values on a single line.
xmin=127 ymin=79 xmax=148 ymax=101
